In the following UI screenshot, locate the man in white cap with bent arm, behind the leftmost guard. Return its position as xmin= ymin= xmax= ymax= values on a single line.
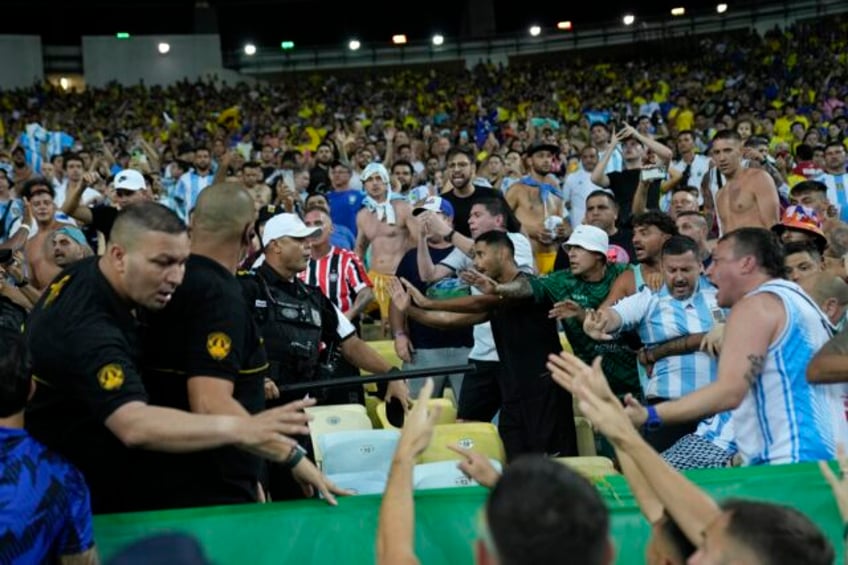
xmin=62 ymin=169 xmax=152 ymax=240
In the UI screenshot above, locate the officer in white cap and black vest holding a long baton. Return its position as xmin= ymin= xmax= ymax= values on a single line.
xmin=240 ymin=214 xmax=409 ymax=499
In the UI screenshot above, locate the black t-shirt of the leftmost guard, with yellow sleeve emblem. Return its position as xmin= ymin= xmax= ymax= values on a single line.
xmin=26 ymin=257 xmax=147 ymax=513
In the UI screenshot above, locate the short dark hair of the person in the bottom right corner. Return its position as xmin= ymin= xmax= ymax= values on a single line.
xmin=721 ymin=499 xmax=836 ymax=565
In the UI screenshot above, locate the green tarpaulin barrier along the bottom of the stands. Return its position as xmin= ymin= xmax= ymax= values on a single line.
xmin=94 ymin=464 xmax=842 ymax=565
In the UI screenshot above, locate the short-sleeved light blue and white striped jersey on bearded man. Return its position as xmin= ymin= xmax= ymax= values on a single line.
xmin=613 ymin=276 xmax=718 ymax=398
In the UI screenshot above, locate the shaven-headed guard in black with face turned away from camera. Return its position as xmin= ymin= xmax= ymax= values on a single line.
xmin=142 ymin=183 xmax=343 ymax=508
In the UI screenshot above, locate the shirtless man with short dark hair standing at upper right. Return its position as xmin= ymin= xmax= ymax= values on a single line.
xmin=711 ymin=130 xmax=780 ymax=234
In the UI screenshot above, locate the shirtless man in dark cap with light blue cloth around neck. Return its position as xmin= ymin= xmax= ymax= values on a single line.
xmin=506 ymin=142 xmax=571 ymax=275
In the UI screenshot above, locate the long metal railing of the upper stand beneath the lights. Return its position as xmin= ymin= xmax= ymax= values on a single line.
xmin=224 ymin=0 xmax=848 ymax=76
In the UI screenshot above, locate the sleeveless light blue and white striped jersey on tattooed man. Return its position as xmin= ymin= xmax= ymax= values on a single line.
xmin=733 ymin=279 xmax=837 ymax=465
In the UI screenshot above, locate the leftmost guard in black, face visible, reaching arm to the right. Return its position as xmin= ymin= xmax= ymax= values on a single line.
xmin=26 ymin=202 xmax=312 ymax=513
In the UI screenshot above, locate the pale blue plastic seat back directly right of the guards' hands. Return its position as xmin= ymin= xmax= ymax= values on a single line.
xmin=318 ymin=430 xmax=400 ymax=475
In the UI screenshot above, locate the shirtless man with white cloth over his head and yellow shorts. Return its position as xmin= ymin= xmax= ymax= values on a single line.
xmin=354 ymin=163 xmax=418 ymax=329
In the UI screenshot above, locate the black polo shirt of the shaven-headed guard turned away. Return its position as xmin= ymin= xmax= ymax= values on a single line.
xmin=141 ymin=255 xmax=268 ymax=508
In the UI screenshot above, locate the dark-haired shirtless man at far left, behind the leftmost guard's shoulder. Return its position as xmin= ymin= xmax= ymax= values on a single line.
xmin=21 ymin=177 xmax=68 ymax=290
